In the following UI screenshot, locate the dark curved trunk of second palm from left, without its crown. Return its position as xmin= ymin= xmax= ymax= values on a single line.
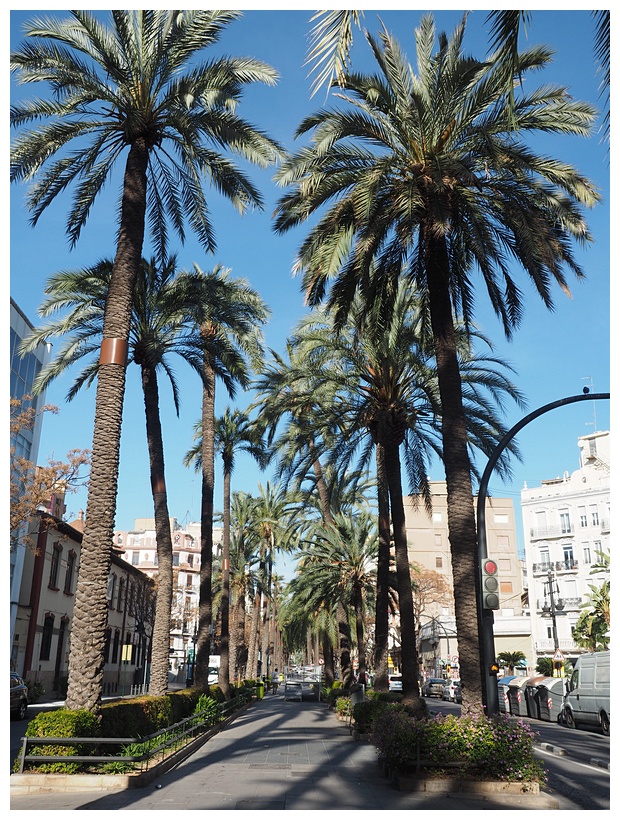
xmin=142 ymin=364 xmax=173 ymax=696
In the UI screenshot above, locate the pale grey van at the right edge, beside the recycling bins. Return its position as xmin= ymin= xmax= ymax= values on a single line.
xmin=564 ymin=652 xmax=610 ymax=735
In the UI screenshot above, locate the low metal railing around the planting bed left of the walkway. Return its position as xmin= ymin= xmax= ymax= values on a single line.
xmin=19 ymin=694 xmax=251 ymax=774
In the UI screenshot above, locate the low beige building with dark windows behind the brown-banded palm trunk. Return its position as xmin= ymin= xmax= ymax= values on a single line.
xmin=11 ymin=513 xmax=155 ymax=698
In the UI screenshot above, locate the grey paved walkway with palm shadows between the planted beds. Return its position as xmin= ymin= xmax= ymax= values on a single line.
xmin=10 ymin=694 xmax=553 ymax=812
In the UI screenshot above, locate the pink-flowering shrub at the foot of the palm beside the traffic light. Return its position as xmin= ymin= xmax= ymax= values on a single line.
xmin=371 ymin=705 xmax=544 ymax=782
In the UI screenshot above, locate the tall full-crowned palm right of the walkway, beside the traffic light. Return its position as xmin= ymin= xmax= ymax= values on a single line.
xmin=275 ymin=16 xmax=599 ymax=711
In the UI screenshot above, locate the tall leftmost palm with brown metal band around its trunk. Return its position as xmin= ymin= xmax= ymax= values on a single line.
xmin=11 ymin=10 xmax=281 ymax=710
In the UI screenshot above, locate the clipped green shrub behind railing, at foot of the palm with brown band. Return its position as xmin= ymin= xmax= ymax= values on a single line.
xmin=20 ymin=709 xmax=101 ymax=774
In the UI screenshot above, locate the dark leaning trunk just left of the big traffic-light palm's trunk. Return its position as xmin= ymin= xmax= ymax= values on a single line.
xmin=384 ymin=439 xmax=424 ymax=715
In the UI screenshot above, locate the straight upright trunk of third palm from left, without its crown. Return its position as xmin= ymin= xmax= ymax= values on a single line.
xmin=196 ymin=353 xmax=215 ymax=691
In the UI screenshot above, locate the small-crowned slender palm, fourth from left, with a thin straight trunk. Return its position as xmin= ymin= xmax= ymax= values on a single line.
xmin=183 ymin=408 xmax=266 ymax=700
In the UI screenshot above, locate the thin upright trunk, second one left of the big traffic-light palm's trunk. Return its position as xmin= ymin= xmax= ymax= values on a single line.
xmin=373 ymin=443 xmax=390 ymax=692
